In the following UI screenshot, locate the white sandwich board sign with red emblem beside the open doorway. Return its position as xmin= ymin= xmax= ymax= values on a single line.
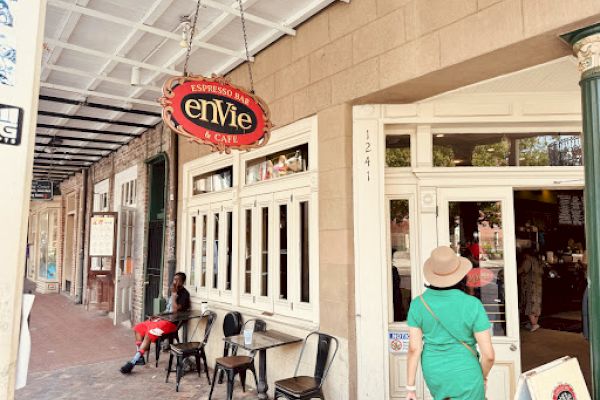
xmin=514 ymin=356 xmax=592 ymax=400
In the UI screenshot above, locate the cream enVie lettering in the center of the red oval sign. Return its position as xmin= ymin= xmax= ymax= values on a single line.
xmin=184 ymin=99 xmax=252 ymax=130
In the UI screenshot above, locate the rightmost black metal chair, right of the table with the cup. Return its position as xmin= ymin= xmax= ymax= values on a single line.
xmin=274 ymin=332 xmax=339 ymax=400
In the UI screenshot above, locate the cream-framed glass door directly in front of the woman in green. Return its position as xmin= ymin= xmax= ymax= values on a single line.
xmin=437 ymin=187 xmax=521 ymax=400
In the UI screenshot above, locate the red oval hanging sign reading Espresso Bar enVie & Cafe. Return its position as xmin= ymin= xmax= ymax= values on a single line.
xmin=160 ymin=76 xmax=272 ymax=153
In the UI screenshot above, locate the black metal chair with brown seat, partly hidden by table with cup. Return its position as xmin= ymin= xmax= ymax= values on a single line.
xmin=208 ymin=319 xmax=267 ymax=400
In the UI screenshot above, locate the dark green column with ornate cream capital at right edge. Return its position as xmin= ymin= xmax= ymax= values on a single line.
xmin=563 ymin=24 xmax=600 ymax=398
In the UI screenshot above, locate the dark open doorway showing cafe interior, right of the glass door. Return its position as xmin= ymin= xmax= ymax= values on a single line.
xmin=514 ymin=190 xmax=591 ymax=387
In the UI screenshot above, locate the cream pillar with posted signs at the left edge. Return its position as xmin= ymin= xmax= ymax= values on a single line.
xmin=0 ymin=1 xmax=46 ymax=400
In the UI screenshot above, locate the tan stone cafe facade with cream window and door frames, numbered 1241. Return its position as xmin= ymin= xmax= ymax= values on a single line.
xmin=178 ymin=0 xmax=600 ymax=399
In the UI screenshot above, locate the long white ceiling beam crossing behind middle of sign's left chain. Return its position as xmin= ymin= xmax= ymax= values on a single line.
xmin=48 ymin=0 xmax=245 ymax=60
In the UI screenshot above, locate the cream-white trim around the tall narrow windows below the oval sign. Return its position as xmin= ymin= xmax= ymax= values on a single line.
xmin=179 ymin=117 xmax=319 ymax=322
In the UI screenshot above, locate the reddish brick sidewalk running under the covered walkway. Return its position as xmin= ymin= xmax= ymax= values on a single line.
xmin=15 ymin=288 xmax=256 ymax=400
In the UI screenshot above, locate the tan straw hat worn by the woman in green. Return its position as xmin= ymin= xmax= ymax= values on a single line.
xmin=423 ymin=246 xmax=473 ymax=288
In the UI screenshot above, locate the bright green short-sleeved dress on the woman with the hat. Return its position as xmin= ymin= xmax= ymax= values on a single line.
xmin=407 ymin=289 xmax=490 ymax=400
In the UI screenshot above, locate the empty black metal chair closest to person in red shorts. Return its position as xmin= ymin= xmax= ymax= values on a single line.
xmin=165 ymin=310 xmax=217 ymax=392
